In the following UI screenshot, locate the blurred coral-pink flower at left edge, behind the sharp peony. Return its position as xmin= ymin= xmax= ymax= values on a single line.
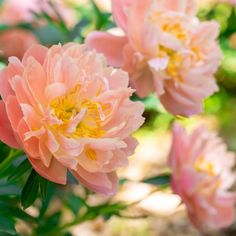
xmin=0 ymin=29 xmax=38 ymax=59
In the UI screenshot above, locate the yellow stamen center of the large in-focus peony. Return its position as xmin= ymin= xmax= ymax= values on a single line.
xmin=50 ymin=86 xmax=109 ymax=138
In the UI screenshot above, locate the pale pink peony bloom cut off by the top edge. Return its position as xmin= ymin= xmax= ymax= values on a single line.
xmin=86 ymin=0 xmax=221 ymax=116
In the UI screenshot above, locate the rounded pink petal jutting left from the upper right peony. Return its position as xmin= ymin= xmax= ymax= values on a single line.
xmin=86 ymin=32 xmax=127 ymax=67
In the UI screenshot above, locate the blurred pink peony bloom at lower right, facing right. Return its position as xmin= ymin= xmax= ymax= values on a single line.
xmin=169 ymin=124 xmax=236 ymax=231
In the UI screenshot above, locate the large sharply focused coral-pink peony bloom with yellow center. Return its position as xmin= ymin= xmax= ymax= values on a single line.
xmin=0 ymin=43 xmax=144 ymax=195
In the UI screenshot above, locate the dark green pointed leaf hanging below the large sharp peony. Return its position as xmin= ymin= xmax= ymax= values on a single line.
xmin=21 ymin=170 xmax=39 ymax=209
